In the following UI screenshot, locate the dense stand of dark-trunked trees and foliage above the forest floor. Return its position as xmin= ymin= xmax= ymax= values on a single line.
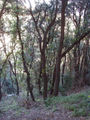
xmin=0 ymin=0 xmax=90 ymax=101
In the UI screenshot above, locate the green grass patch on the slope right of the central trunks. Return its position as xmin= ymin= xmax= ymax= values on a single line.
xmin=45 ymin=91 xmax=90 ymax=116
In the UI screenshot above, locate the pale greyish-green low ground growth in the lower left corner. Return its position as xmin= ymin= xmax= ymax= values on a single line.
xmin=0 ymin=95 xmax=29 ymax=117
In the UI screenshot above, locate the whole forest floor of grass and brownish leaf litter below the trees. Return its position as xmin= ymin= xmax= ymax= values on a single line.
xmin=0 ymin=87 xmax=90 ymax=120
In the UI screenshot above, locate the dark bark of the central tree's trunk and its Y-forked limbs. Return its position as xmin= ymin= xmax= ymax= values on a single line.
xmin=30 ymin=0 xmax=58 ymax=99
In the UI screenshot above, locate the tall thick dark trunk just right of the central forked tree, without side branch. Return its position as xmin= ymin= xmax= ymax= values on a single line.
xmin=54 ymin=0 xmax=68 ymax=96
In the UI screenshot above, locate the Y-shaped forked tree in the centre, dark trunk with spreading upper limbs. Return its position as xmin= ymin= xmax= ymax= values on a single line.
xmin=30 ymin=0 xmax=58 ymax=99
